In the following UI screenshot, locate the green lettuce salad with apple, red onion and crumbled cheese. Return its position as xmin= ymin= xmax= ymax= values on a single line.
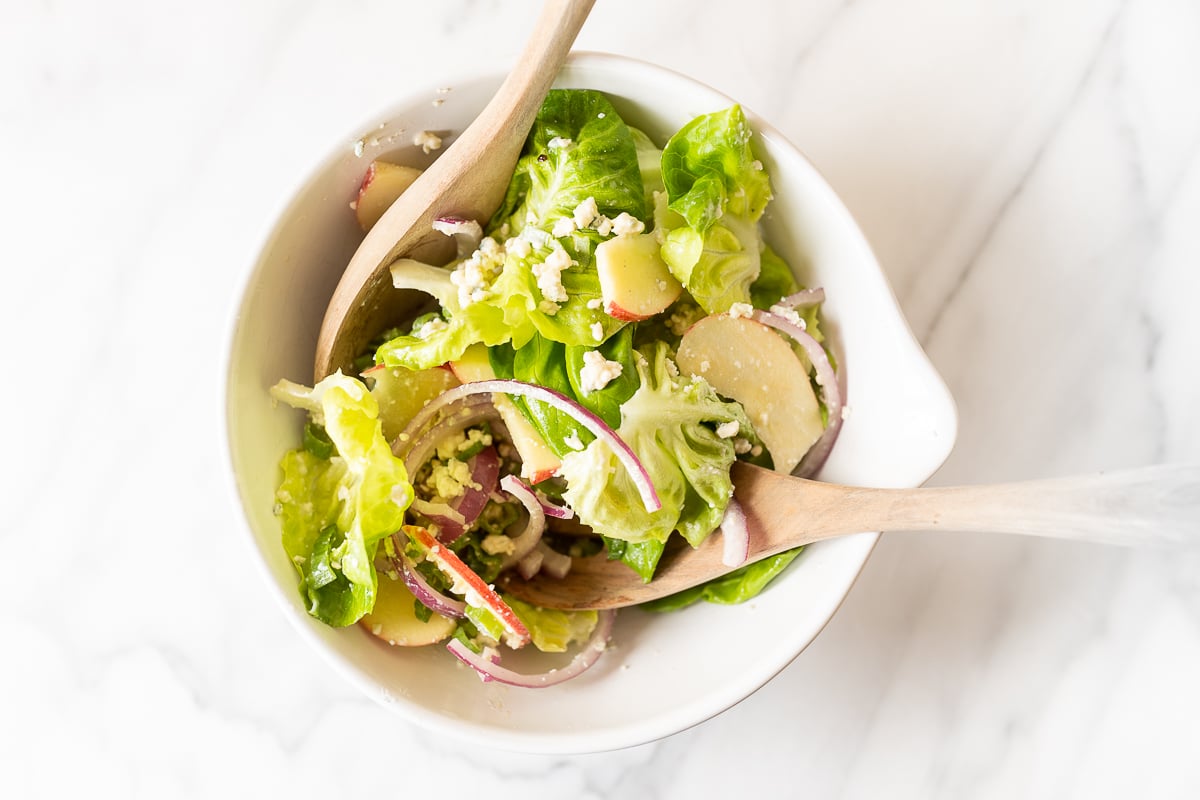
xmin=271 ymin=90 xmax=842 ymax=687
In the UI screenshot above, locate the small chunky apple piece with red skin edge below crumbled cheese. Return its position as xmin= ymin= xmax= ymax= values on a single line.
xmin=596 ymin=234 xmax=683 ymax=321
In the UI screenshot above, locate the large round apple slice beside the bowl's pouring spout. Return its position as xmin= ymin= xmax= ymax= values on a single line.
xmin=676 ymin=314 xmax=824 ymax=473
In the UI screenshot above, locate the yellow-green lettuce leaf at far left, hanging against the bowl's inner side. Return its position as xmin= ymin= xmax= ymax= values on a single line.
xmin=271 ymin=372 xmax=413 ymax=626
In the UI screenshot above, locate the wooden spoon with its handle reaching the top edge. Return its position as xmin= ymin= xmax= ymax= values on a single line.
xmin=313 ymin=0 xmax=595 ymax=380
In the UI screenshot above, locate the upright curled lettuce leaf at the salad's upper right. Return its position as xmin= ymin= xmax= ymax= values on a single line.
xmin=656 ymin=106 xmax=770 ymax=313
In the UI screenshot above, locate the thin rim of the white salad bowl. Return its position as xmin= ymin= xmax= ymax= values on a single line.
xmin=217 ymin=50 xmax=958 ymax=754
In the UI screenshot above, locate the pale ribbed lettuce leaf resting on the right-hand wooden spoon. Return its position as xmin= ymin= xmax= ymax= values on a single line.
xmin=559 ymin=342 xmax=751 ymax=554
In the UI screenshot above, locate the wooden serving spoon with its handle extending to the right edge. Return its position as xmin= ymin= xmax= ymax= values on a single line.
xmin=502 ymin=462 xmax=1200 ymax=609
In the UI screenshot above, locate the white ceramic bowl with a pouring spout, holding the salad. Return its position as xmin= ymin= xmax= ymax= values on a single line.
xmin=227 ymin=54 xmax=956 ymax=753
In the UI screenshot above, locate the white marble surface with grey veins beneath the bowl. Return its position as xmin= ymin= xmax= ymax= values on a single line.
xmin=0 ymin=0 xmax=1200 ymax=799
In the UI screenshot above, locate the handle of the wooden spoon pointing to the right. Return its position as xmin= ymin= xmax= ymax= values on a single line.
xmin=739 ymin=465 xmax=1200 ymax=552
